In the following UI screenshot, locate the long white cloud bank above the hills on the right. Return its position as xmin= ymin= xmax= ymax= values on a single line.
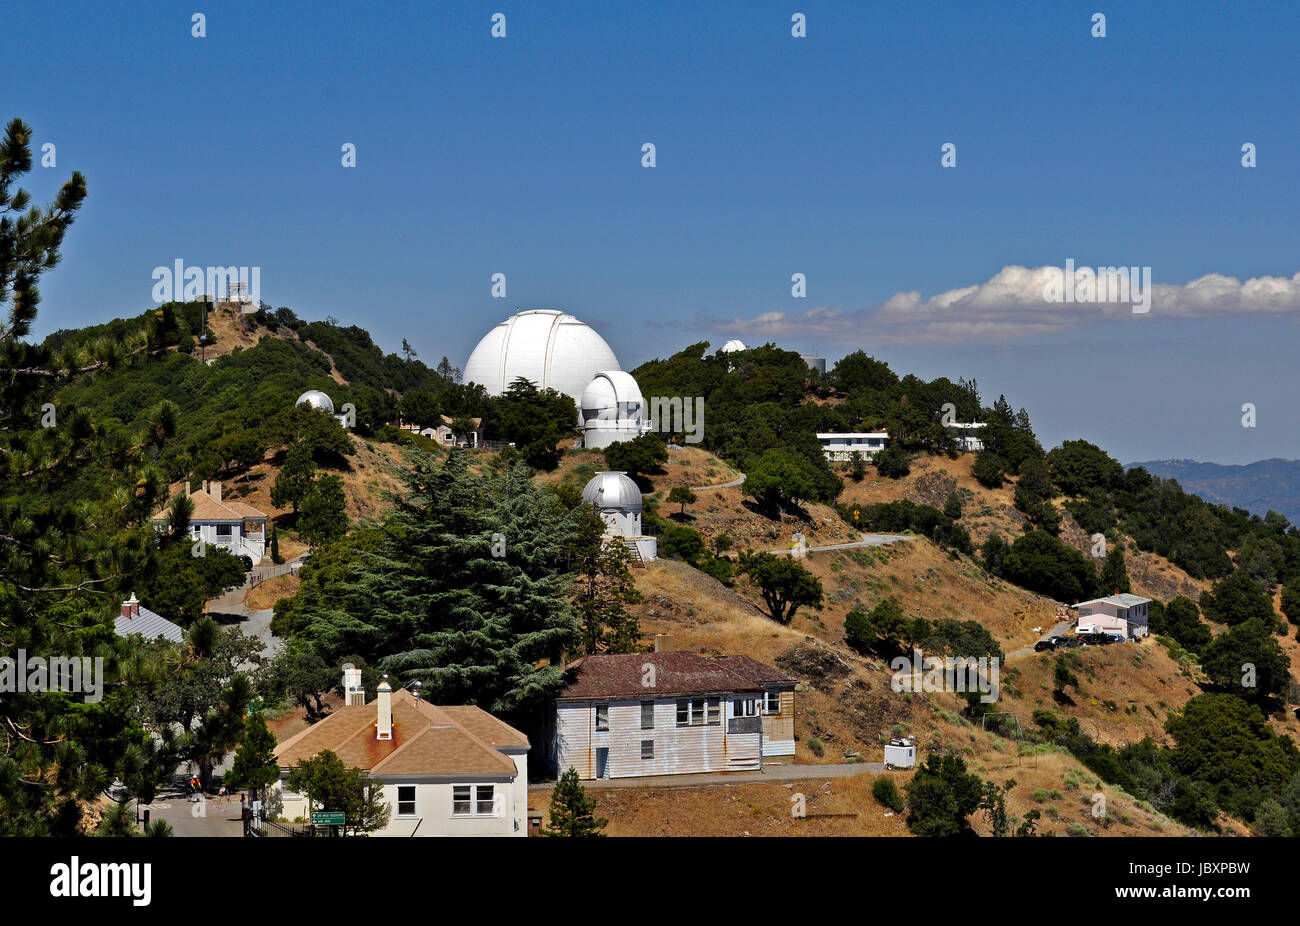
xmin=709 ymin=265 xmax=1300 ymax=345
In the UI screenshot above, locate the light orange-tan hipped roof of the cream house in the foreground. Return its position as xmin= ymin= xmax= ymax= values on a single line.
xmin=276 ymin=688 xmax=528 ymax=778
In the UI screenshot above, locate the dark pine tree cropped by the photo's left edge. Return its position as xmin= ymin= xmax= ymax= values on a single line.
xmin=0 ymin=120 xmax=176 ymax=835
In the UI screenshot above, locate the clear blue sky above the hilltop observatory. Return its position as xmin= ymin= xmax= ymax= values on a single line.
xmin=10 ymin=0 xmax=1300 ymax=463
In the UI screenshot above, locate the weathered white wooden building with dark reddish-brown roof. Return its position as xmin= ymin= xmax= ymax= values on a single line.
xmin=549 ymin=637 xmax=796 ymax=778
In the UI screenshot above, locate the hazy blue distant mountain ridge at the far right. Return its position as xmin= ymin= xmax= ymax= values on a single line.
xmin=1125 ymin=458 xmax=1300 ymax=523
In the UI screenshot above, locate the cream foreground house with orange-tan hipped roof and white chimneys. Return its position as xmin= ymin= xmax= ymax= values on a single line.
xmin=276 ymin=666 xmax=528 ymax=836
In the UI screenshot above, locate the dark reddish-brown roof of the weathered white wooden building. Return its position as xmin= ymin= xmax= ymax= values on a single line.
xmin=556 ymin=652 xmax=796 ymax=701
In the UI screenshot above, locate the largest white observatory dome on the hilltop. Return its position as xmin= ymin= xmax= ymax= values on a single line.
xmin=464 ymin=308 xmax=619 ymax=403
